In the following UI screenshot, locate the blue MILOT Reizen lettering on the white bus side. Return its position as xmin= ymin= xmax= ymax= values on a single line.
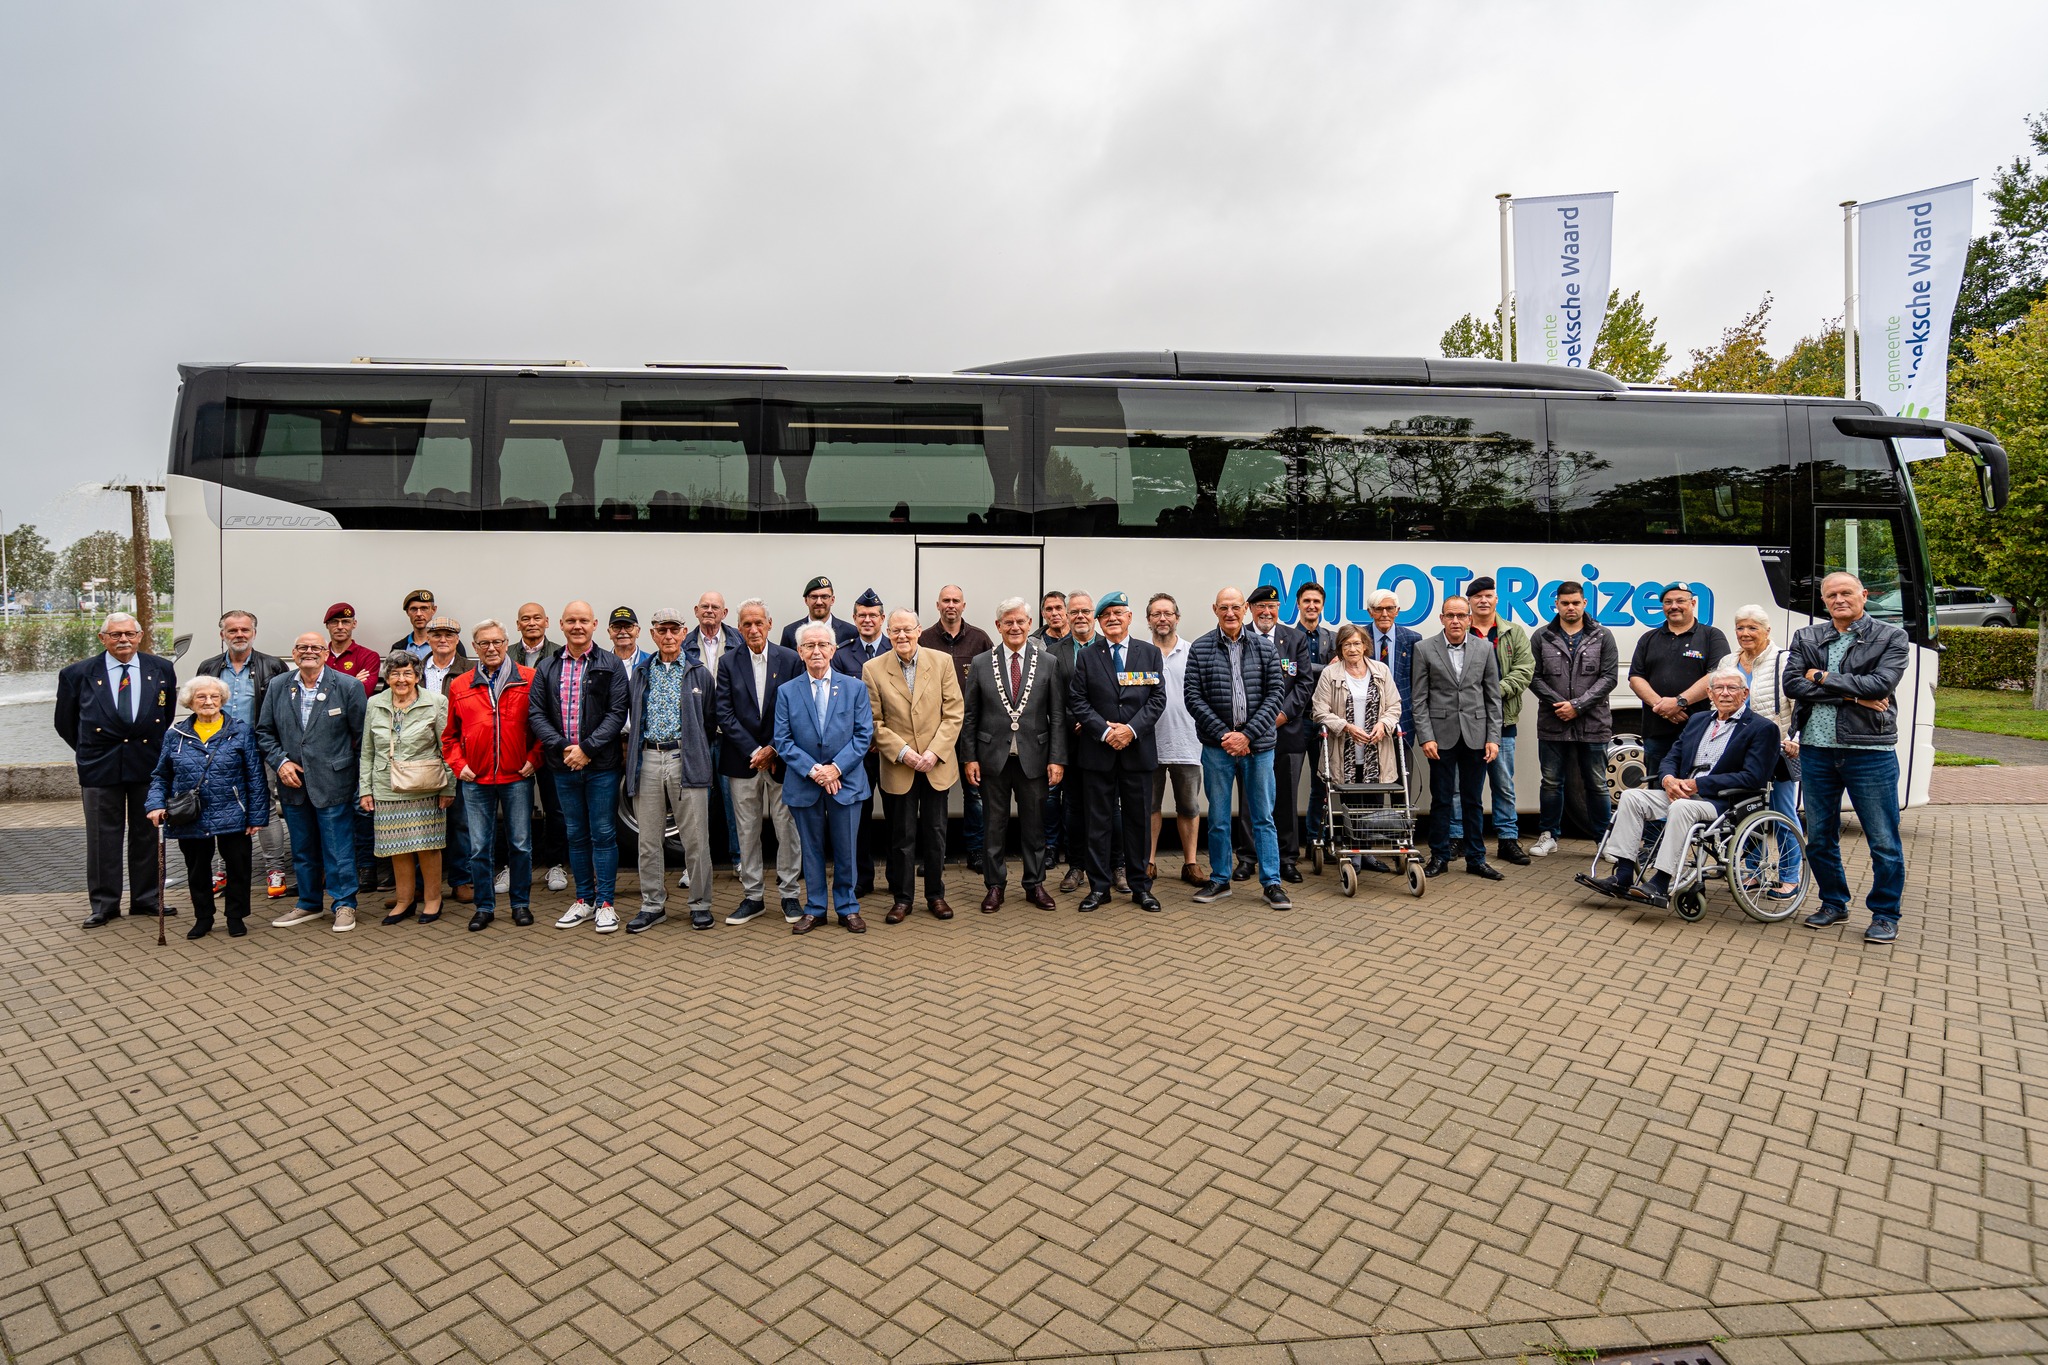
xmin=1260 ymin=563 xmax=1714 ymax=628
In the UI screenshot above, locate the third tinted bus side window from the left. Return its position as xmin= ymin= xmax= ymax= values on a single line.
xmin=754 ymin=381 xmax=1030 ymax=532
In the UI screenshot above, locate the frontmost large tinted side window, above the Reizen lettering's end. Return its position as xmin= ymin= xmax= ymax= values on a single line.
xmin=1550 ymin=399 xmax=1792 ymax=544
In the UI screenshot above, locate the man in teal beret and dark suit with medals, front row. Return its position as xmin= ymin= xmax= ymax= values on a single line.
xmin=1067 ymin=591 xmax=1165 ymax=913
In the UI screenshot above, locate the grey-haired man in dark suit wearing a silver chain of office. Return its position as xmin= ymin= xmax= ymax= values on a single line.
xmin=961 ymin=598 xmax=1067 ymax=915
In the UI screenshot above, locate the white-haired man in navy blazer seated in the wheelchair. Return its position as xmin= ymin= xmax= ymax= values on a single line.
xmin=1577 ymin=667 xmax=1780 ymax=907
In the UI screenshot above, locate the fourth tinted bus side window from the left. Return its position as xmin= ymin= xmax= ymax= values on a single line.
xmin=1036 ymin=385 xmax=1296 ymax=538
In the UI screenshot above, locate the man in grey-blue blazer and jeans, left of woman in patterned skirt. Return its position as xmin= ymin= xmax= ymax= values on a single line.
xmin=256 ymin=630 xmax=377 ymax=933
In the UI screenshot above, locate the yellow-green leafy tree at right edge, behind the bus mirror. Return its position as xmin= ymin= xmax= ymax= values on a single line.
xmin=1913 ymin=299 xmax=2048 ymax=710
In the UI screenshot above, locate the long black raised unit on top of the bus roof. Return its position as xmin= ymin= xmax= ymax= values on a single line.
xmin=961 ymin=350 xmax=1628 ymax=393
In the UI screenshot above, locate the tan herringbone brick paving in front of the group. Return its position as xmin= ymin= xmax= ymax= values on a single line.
xmin=0 ymin=806 xmax=2048 ymax=1365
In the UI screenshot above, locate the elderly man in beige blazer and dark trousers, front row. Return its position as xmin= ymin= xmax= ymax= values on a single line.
xmin=860 ymin=612 xmax=967 ymax=925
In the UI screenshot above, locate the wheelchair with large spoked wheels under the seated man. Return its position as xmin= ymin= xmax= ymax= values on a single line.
xmin=1575 ymin=790 xmax=1810 ymax=925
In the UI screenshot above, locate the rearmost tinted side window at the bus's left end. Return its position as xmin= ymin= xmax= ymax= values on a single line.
xmin=215 ymin=372 xmax=477 ymax=530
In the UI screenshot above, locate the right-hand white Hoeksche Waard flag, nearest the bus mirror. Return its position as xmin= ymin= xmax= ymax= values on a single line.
xmin=1855 ymin=180 xmax=1976 ymax=460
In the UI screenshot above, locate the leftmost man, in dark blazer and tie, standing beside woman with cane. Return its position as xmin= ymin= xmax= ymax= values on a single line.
xmin=57 ymin=612 xmax=178 ymax=929
